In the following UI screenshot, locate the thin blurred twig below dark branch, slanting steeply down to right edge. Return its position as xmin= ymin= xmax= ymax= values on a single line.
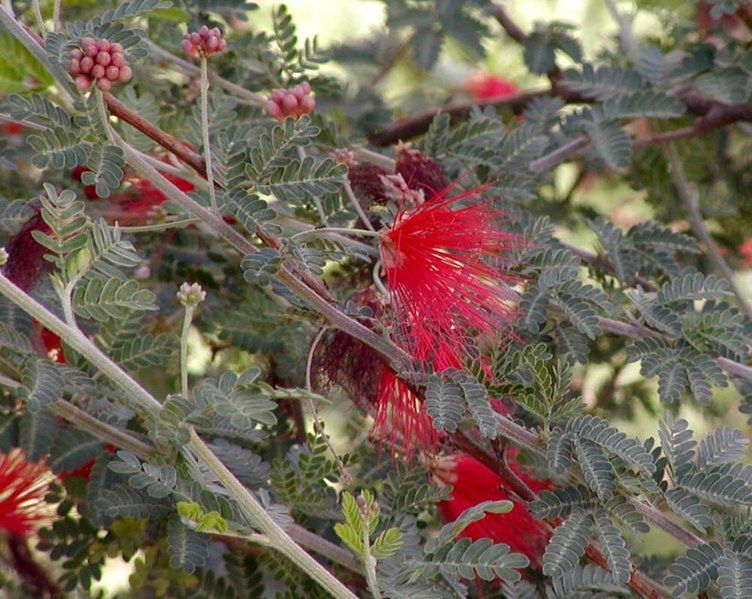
xmin=665 ymin=145 xmax=752 ymax=319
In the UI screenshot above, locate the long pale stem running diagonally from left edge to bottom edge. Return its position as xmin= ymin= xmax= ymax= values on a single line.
xmin=0 ymin=273 xmax=356 ymax=599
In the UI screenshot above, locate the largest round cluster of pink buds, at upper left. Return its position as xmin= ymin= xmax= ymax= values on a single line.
xmin=68 ymin=37 xmax=133 ymax=92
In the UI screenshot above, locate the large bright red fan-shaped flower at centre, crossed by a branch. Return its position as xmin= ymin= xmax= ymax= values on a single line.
xmin=375 ymin=187 xmax=515 ymax=452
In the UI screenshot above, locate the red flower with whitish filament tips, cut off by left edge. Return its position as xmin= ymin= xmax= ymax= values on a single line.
xmin=0 ymin=448 xmax=54 ymax=535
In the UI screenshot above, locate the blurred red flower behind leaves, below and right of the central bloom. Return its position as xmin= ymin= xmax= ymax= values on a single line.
xmin=431 ymin=454 xmax=551 ymax=567
